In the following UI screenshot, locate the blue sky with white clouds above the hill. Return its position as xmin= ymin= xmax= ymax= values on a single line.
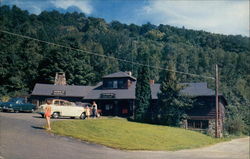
xmin=0 ymin=0 xmax=249 ymax=36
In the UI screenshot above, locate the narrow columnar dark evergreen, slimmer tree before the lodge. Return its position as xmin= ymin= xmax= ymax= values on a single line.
xmin=135 ymin=66 xmax=151 ymax=122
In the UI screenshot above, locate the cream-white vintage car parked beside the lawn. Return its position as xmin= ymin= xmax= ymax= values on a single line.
xmin=37 ymin=99 xmax=86 ymax=119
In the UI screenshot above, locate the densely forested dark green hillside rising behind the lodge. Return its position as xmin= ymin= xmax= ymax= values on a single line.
xmin=0 ymin=6 xmax=250 ymax=105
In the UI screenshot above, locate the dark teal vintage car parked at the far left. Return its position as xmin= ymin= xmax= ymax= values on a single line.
xmin=1 ymin=98 xmax=36 ymax=112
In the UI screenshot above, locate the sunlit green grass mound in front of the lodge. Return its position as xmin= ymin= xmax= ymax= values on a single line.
xmin=52 ymin=118 xmax=229 ymax=151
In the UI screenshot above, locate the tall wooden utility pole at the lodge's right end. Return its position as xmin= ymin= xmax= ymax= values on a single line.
xmin=215 ymin=64 xmax=220 ymax=138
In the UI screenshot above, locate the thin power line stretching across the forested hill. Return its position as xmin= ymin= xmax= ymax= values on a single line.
xmin=0 ymin=30 xmax=215 ymax=80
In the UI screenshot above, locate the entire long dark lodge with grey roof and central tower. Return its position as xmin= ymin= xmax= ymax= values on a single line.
xmin=30 ymin=72 xmax=227 ymax=135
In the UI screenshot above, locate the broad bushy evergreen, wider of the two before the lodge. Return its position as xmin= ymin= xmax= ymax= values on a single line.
xmin=158 ymin=63 xmax=191 ymax=126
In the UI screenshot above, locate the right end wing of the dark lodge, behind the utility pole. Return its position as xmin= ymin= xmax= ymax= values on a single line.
xmin=181 ymin=83 xmax=227 ymax=135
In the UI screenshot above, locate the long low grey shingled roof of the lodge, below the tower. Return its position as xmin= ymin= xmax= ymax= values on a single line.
xmin=31 ymin=82 xmax=218 ymax=100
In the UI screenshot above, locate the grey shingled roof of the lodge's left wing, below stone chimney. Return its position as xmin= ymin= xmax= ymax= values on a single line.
xmin=31 ymin=83 xmax=93 ymax=97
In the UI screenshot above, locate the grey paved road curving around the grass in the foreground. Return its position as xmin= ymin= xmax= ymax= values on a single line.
xmin=0 ymin=113 xmax=249 ymax=159
